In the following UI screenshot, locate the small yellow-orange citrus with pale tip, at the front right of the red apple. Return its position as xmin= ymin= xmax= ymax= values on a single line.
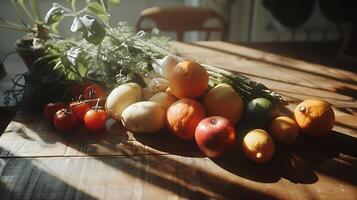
xmin=242 ymin=129 xmax=275 ymax=163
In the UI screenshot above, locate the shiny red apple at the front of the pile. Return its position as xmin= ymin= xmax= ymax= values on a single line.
xmin=195 ymin=116 xmax=236 ymax=158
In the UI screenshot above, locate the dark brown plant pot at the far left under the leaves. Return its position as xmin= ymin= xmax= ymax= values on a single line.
xmin=16 ymin=37 xmax=44 ymax=70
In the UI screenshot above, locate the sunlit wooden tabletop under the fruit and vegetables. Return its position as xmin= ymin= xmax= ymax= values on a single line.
xmin=0 ymin=42 xmax=357 ymax=200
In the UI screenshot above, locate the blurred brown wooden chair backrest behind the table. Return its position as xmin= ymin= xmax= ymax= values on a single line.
xmin=136 ymin=7 xmax=226 ymax=41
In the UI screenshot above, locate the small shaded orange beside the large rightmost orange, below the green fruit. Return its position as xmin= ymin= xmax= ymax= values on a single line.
xmin=270 ymin=116 xmax=299 ymax=144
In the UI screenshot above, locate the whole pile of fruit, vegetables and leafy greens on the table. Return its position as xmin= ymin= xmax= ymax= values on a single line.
xmin=2 ymin=0 xmax=335 ymax=163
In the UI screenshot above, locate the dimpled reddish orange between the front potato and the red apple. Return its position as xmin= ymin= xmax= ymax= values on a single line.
xmin=166 ymin=98 xmax=206 ymax=140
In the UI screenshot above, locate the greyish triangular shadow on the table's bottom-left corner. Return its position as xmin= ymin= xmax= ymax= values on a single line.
xmin=0 ymin=147 xmax=96 ymax=200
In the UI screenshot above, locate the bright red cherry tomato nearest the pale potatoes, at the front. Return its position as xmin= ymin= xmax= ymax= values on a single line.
xmin=84 ymin=108 xmax=107 ymax=131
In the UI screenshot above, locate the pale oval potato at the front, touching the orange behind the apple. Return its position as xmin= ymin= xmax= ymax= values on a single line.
xmin=121 ymin=101 xmax=166 ymax=133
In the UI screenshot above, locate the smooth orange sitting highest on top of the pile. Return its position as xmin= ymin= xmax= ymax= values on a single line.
xmin=168 ymin=61 xmax=208 ymax=98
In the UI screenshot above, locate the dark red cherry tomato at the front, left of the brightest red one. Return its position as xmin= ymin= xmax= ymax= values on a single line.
xmin=53 ymin=109 xmax=77 ymax=131
